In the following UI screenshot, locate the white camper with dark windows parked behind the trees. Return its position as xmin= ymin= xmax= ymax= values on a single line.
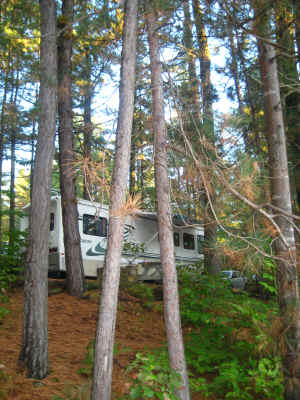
xmin=21 ymin=196 xmax=203 ymax=280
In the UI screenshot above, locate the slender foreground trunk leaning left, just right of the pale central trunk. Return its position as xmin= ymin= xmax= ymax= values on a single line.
xmin=147 ymin=12 xmax=190 ymax=400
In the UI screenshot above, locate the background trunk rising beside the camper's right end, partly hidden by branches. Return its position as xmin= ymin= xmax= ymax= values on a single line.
xmin=193 ymin=0 xmax=221 ymax=275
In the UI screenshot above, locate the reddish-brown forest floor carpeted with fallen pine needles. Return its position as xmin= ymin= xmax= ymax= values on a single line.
xmin=0 ymin=280 xmax=206 ymax=400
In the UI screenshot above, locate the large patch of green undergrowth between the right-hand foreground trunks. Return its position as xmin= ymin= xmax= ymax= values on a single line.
xmin=180 ymin=274 xmax=283 ymax=400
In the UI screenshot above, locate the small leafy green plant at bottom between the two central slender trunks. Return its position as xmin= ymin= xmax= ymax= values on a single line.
xmin=128 ymin=350 xmax=181 ymax=400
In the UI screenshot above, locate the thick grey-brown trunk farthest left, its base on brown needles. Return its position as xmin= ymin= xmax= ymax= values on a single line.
xmin=19 ymin=0 xmax=57 ymax=379
